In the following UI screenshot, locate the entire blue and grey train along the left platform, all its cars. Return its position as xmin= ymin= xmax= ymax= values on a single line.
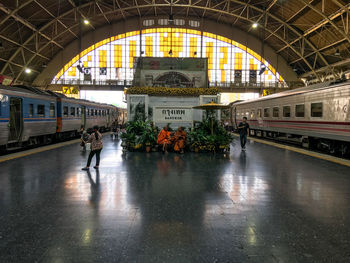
xmin=0 ymin=86 xmax=118 ymax=152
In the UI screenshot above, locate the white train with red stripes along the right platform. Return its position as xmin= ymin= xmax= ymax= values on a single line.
xmin=231 ymin=81 xmax=350 ymax=155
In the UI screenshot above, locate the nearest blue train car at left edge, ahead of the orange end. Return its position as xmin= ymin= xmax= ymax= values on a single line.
xmin=0 ymin=86 xmax=57 ymax=148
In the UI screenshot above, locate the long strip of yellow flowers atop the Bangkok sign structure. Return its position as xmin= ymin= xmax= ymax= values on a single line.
xmin=126 ymin=87 xmax=219 ymax=96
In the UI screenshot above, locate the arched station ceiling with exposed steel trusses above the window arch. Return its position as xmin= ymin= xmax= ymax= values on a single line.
xmin=0 ymin=0 xmax=350 ymax=84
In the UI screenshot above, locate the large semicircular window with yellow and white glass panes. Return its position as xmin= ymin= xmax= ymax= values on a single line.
xmin=52 ymin=28 xmax=284 ymax=85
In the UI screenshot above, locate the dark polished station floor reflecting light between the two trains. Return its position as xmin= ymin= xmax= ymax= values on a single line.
xmin=0 ymin=136 xmax=350 ymax=263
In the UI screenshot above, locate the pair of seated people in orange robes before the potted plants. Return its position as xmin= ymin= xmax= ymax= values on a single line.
xmin=157 ymin=126 xmax=187 ymax=153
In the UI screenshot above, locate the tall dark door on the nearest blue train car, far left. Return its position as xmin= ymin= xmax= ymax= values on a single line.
xmin=9 ymin=98 xmax=23 ymax=141
